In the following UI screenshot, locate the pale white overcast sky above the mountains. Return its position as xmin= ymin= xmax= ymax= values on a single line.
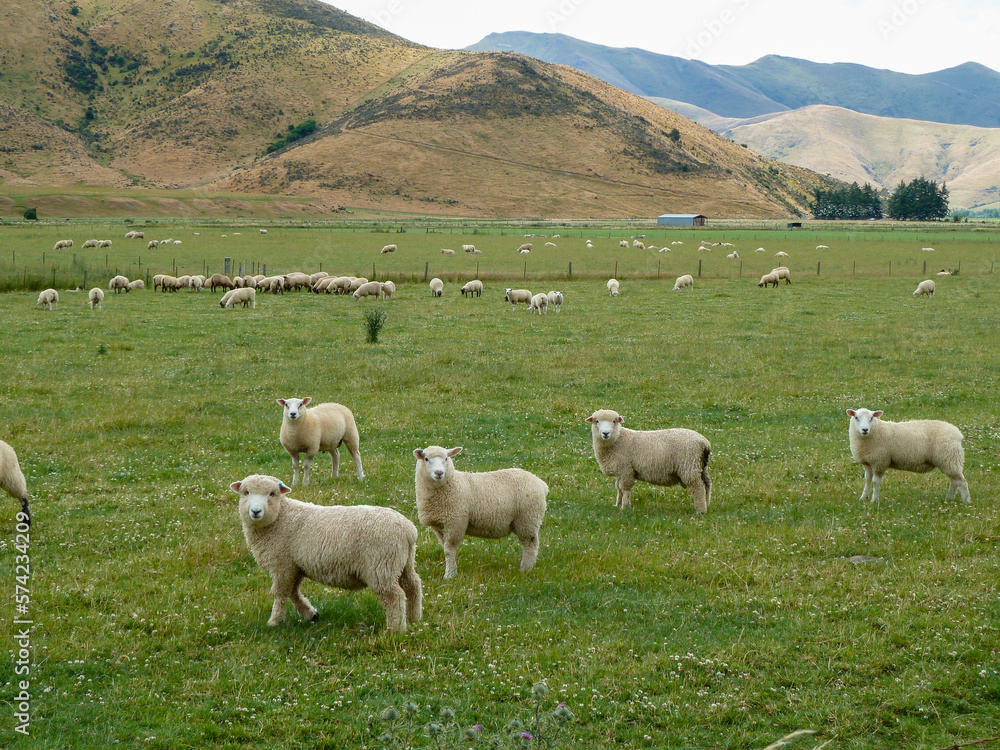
xmin=325 ymin=0 xmax=1000 ymax=73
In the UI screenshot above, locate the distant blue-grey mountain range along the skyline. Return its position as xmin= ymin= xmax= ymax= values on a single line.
xmin=468 ymin=31 xmax=1000 ymax=128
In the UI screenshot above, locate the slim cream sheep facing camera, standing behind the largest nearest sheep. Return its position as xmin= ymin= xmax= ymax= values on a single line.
xmin=277 ymin=396 xmax=365 ymax=487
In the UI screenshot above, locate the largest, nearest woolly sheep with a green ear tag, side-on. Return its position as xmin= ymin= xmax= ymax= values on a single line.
xmin=229 ymin=474 xmax=423 ymax=632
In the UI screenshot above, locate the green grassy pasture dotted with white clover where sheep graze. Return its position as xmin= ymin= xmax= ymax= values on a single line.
xmin=0 ymin=224 xmax=1000 ymax=750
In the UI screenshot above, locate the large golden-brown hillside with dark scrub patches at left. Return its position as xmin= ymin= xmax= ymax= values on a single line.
xmin=0 ymin=0 xmax=828 ymax=217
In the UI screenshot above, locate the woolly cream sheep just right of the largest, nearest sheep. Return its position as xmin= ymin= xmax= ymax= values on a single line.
xmin=413 ymin=445 xmax=549 ymax=580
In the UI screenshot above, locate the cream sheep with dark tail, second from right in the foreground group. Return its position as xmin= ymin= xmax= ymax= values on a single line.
xmin=586 ymin=409 xmax=712 ymax=514
